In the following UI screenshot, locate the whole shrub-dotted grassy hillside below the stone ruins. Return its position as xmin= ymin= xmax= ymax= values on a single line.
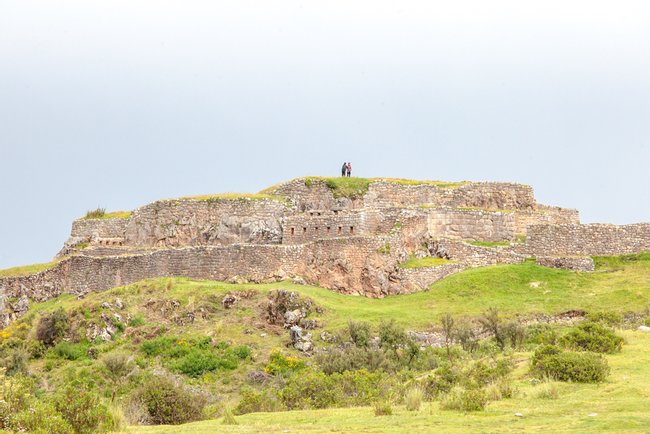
xmin=0 ymin=254 xmax=650 ymax=433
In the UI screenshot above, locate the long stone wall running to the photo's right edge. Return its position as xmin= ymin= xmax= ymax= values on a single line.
xmin=525 ymin=223 xmax=650 ymax=256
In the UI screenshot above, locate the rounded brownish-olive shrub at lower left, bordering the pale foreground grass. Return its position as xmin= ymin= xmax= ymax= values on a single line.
xmin=129 ymin=376 xmax=205 ymax=425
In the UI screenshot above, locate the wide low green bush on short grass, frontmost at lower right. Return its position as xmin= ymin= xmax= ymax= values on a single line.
xmin=531 ymin=345 xmax=609 ymax=383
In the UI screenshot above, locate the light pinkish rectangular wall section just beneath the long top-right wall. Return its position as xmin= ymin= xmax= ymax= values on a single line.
xmin=428 ymin=209 xmax=516 ymax=242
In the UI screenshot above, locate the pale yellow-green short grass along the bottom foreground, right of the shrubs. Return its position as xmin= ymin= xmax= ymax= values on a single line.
xmin=129 ymin=331 xmax=650 ymax=433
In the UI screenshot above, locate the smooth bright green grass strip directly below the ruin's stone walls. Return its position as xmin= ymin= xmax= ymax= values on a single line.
xmin=27 ymin=256 xmax=650 ymax=328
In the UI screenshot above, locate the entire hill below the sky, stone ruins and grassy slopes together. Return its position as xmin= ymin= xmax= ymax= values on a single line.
xmin=0 ymin=177 xmax=650 ymax=433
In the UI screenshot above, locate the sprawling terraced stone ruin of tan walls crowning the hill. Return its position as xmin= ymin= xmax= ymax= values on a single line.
xmin=0 ymin=178 xmax=650 ymax=327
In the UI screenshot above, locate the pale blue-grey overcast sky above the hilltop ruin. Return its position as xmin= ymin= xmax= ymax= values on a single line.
xmin=0 ymin=0 xmax=650 ymax=268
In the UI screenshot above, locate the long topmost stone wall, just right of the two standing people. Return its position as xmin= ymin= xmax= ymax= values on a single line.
xmin=364 ymin=181 xmax=535 ymax=210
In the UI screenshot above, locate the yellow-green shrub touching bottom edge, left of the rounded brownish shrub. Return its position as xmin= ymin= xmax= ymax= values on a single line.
xmin=53 ymin=383 xmax=112 ymax=433
